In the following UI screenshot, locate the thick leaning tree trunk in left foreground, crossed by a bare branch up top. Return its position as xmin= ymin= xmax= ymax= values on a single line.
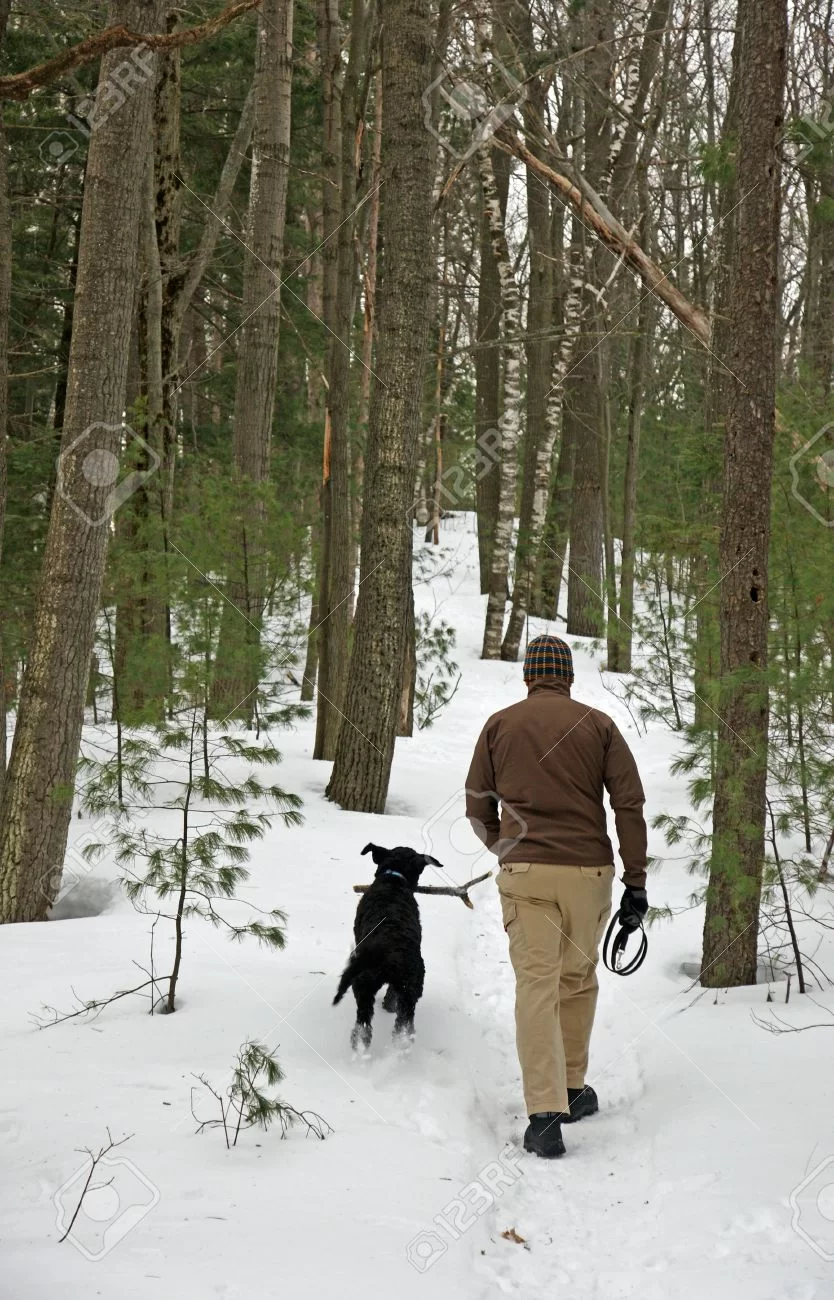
xmin=0 ymin=0 xmax=162 ymax=922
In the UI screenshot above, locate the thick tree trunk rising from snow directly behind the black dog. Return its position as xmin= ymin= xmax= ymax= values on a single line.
xmin=327 ymin=0 xmax=434 ymax=813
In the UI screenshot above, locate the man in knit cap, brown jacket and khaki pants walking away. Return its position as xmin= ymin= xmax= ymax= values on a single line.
xmin=466 ymin=636 xmax=648 ymax=1158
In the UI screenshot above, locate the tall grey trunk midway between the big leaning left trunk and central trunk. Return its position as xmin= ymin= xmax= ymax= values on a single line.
xmin=212 ymin=0 xmax=292 ymax=718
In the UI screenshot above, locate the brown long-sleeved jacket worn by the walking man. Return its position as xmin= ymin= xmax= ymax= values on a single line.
xmin=466 ymin=677 xmax=646 ymax=888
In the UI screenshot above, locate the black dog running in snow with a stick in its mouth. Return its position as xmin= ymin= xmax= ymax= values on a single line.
xmin=333 ymin=844 xmax=443 ymax=1048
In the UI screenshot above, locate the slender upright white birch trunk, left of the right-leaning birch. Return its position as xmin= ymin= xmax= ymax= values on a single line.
xmin=478 ymin=144 xmax=524 ymax=659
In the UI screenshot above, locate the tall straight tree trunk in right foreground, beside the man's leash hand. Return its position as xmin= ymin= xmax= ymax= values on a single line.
xmin=701 ymin=0 xmax=787 ymax=988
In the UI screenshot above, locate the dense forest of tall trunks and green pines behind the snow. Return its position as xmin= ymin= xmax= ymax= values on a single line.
xmin=0 ymin=0 xmax=834 ymax=985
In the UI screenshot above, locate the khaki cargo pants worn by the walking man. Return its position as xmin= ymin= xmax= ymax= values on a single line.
xmin=498 ymin=862 xmax=614 ymax=1115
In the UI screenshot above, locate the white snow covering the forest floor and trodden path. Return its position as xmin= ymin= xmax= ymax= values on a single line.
xmin=0 ymin=516 xmax=834 ymax=1300
